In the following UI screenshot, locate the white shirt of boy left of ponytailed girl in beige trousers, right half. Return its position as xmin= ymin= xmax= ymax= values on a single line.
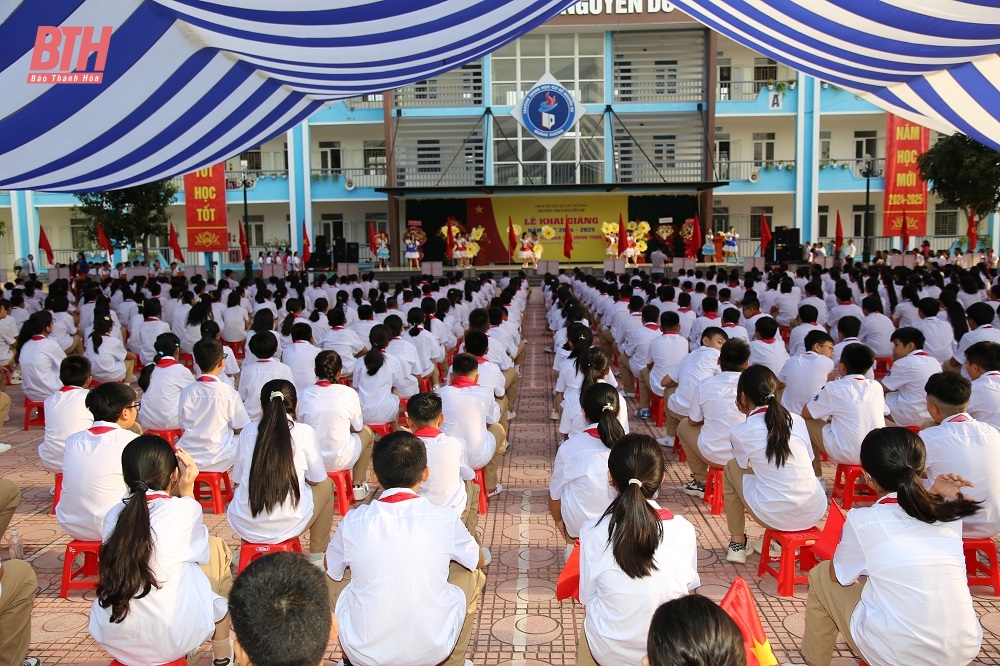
xmin=688 ymin=372 xmax=746 ymax=465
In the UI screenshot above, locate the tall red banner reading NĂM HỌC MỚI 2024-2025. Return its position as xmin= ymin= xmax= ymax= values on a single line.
xmin=882 ymin=113 xmax=930 ymax=236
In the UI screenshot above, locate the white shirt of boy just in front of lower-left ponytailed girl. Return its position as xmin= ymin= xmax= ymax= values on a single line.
xmin=56 ymin=421 xmax=138 ymax=541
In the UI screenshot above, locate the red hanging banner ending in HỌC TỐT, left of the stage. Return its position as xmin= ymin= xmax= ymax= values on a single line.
xmin=184 ymin=162 xmax=229 ymax=252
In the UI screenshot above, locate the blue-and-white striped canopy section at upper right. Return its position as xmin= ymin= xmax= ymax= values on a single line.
xmin=673 ymin=0 xmax=1000 ymax=149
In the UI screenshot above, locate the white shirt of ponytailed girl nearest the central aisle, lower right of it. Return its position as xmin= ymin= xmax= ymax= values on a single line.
xmin=580 ymin=501 xmax=701 ymax=664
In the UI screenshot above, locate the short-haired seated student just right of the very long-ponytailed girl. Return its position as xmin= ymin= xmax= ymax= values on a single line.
xmin=297 ymin=351 xmax=375 ymax=502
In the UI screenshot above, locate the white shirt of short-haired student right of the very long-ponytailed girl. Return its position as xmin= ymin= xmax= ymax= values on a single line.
xmin=296 ymin=380 xmax=364 ymax=470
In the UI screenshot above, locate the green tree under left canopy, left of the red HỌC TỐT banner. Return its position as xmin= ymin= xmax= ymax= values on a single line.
xmin=76 ymin=180 xmax=177 ymax=257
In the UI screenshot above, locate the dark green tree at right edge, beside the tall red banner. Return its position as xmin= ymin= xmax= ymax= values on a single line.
xmin=917 ymin=134 xmax=1000 ymax=246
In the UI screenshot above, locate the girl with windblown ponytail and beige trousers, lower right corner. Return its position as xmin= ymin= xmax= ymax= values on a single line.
xmin=802 ymin=428 xmax=983 ymax=666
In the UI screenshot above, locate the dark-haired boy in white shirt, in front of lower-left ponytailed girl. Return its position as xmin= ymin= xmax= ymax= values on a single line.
xmin=56 ymin=382 xmax=139 ymax=541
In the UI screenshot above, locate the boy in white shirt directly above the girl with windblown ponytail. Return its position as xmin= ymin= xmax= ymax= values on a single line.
xmin=881 ymin=326 xmax=941 ymax=427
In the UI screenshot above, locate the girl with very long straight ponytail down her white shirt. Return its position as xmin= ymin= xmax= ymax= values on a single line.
xmin=227 ymin=379 xmax=333 ymax=561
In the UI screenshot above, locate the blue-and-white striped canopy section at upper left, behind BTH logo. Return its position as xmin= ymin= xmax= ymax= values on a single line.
xmin=0 ymin=0 xmax=574 ymax=192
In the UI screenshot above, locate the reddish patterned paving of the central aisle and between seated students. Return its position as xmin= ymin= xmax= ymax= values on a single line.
xmin=0 ymin=293 xmax=1000 ymax=666
